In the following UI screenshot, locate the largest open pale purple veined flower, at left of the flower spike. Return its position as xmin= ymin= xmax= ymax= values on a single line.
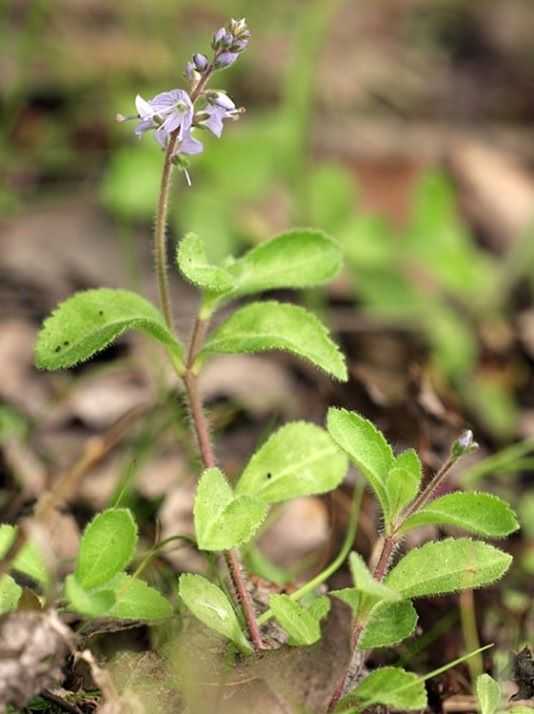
xmin=135 ymin=89 xmax=194 ymax=147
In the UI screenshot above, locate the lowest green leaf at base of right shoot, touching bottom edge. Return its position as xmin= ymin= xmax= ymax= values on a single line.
xmin=335 ymin=667 xmax=427 ymax=714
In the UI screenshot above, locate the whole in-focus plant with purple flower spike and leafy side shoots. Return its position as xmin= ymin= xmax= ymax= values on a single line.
xmin=0 ymin=20 xmax=517 ymax=714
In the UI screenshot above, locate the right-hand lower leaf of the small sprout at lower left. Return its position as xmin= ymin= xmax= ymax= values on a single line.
xmin=106 ymin=573 xmax=172 ymax=622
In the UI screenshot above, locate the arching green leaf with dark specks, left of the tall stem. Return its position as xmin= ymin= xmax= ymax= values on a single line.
xmin=35 ymin=288 xmax=183 ymax=370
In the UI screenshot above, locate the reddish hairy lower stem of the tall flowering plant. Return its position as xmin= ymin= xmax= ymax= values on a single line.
xmin=184 ymin=317 xmax=264 ymax=651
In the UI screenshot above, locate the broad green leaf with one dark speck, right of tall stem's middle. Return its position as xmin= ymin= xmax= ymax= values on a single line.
xmin=236 ymin=422 xmax=347 ymax=503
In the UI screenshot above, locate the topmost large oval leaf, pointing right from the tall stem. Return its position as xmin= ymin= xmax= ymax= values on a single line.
xmin=229 ymin=228 xmax=342 ymax=296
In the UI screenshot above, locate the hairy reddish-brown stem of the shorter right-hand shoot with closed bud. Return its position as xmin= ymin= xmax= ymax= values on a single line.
xmin=328 ymin=444 xmax=460 ymax=712
